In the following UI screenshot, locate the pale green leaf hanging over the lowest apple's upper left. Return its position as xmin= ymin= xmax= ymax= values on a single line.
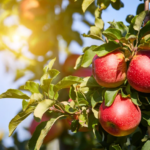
xmin=104 ymin=88 xmax=120 ymax=107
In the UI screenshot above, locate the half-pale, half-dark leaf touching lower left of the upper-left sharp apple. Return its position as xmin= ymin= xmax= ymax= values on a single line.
xmin=80 ymin=76 xmax=100 ymax=87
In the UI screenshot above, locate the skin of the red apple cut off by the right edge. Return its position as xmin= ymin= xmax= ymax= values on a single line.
xmin=127 ymin=51 xmax=150 ymax=93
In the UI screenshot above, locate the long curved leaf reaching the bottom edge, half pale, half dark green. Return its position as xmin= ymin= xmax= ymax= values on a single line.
xmin=29 ymin=115 xmax=65 ymax=150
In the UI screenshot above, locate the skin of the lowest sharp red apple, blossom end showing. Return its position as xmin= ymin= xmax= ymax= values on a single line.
xmin=99 ymin=94 xmax=141 ymax=136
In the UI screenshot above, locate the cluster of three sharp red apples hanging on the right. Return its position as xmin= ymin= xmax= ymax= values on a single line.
xmin=92 ymin=50 xmax=150 ymax=136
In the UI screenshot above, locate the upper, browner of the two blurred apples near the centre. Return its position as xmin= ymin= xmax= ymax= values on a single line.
xmin=62 ymin=54 xmax=80 ymax=75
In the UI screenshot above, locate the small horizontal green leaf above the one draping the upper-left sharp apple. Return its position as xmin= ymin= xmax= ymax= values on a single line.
xmin=103 ymin=28 xmax=122 ymax=40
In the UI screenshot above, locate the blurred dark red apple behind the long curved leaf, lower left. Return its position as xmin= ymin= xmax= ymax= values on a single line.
xmin=29 ymin=115 xmax=64 ymax=144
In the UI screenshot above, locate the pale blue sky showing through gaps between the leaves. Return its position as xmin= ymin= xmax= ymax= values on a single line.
xmin=0 ymin=0 xmax=145 ymax=146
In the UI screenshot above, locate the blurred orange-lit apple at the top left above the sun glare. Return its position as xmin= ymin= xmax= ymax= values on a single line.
xmin=19 ymin=0 xmax=49 ymax=30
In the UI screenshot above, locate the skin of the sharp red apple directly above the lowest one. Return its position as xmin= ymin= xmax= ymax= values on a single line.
xmin=92 ymin=50 xmax=127 ymax=88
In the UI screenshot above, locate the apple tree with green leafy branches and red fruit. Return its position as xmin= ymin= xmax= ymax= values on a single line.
xmin=0 ymin=0 xmax=150 ymax=150
